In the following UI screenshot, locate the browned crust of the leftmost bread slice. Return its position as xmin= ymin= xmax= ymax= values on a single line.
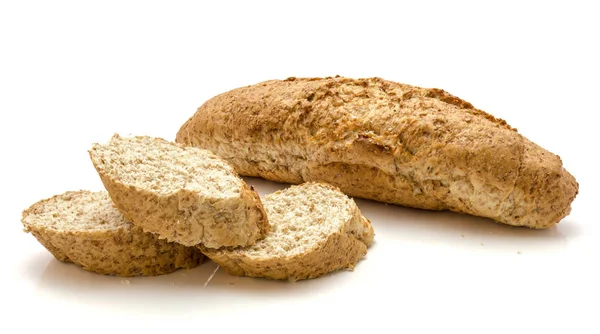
xmin=22 ymin=191 xmax=204 ymax=276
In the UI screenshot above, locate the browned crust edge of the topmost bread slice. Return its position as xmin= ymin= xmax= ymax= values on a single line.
xmin=89 ymin=138 xmax=269 ymax=248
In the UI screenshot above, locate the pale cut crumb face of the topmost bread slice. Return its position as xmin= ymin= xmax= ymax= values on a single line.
xmin=92 ymin=135 xmax=242 ymax=199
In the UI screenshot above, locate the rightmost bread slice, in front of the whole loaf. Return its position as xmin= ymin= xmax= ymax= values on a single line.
xmin=203 ymin=183 xmax=374 ymax=280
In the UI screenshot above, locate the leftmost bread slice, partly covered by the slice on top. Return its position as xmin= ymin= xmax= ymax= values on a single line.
xmin=21 ymin=190 xmax=203 ymax=276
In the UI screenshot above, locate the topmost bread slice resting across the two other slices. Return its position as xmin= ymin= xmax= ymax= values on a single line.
xmin=89 ymin=135 xmax=268 ymax=248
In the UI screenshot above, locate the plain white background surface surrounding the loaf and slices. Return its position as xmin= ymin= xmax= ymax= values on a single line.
xmin=0 ymin=1 xmax=600 ymax=333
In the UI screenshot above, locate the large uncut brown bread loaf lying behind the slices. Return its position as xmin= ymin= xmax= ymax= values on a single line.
xmin=176 ymin=77 xmax=578 ymax=228
